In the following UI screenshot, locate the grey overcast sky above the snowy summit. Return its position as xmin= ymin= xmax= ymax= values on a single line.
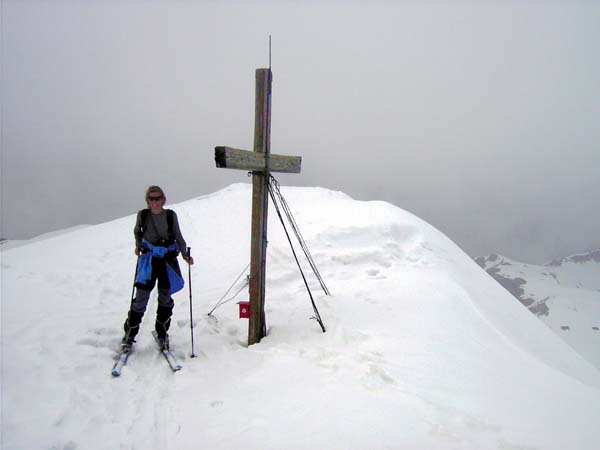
xmin=1 ymin=0 xmax=600 ymax=263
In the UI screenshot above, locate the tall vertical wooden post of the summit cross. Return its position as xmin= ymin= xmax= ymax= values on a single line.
xmin=248 ymin=69 xmax=272 ymax=345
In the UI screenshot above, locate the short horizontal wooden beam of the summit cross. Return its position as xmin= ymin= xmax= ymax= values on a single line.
xmin=215 ymin=147 xmax=302 ymax=173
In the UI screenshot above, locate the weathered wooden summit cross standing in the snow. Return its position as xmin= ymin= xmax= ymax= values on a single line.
xmin=215 ymin=68 xmax=302 ymax=345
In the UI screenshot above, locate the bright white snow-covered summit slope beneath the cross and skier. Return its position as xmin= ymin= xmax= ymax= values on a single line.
xmin=1 ymin=184 xmax=600 ymax=450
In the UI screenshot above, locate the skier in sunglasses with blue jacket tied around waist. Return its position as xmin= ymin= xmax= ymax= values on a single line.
xmin=121 ymin=186 xmax=194 ymax=351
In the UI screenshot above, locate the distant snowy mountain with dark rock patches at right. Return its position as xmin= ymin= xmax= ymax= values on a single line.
xmin=476 ymin=250 xmax=600 ymax=369
